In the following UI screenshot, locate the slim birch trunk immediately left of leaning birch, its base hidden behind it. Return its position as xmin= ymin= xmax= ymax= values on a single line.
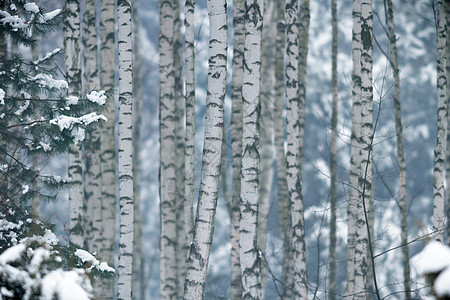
xmin=183 ymin=0 xmax=195 ymax=268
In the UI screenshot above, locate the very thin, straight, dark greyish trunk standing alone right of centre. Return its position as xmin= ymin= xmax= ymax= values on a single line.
xmin=328 ymin=0 xmax=339 ymax=300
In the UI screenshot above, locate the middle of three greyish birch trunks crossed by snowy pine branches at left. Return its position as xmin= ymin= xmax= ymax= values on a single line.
xmin=82 ymin=0 xmax=102 ymax=252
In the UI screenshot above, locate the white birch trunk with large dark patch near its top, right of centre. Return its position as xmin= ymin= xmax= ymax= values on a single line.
xmin=354 ymin=0 xmax=373 ymax=299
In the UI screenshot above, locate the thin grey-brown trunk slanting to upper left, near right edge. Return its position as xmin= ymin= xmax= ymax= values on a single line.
xmin=386 ymin=0 xmax=411 ymax=299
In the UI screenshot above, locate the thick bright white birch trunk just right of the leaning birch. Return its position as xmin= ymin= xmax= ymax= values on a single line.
xmin=239 ymin=0 xmax=264 ymax=299
